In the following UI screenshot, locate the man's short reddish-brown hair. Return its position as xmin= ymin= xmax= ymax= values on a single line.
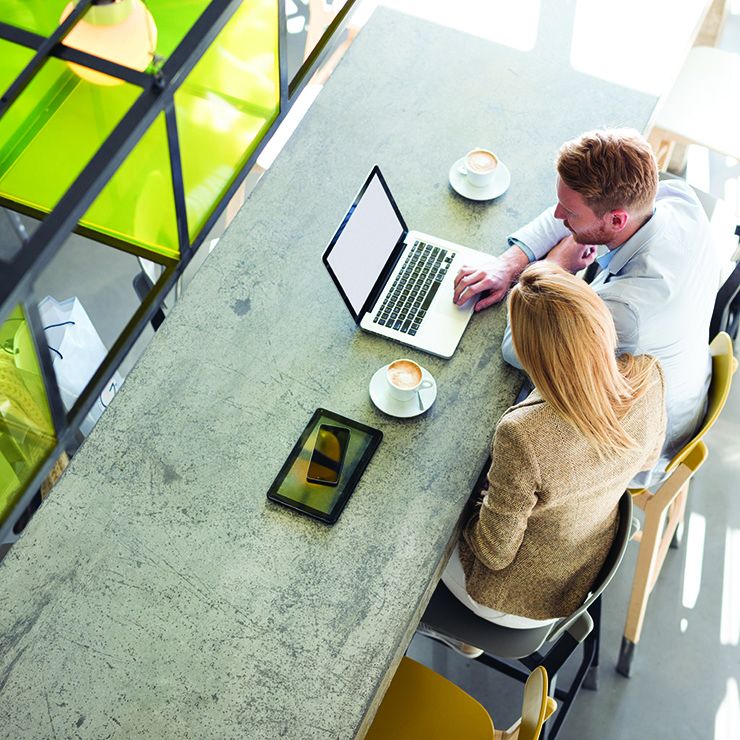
xmin=555 ymin=129 xmax=658 ymax=216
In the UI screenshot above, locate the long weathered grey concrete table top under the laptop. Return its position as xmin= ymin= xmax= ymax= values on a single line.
xmin=0 ymin=4 xmax=700 ymax=740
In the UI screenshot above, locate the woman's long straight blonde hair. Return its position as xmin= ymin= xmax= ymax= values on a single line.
xmin=509 ymin=262 xmax=656 ymax=457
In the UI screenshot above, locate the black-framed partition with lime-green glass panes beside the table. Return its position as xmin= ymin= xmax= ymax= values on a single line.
xmin=0 ymin=0 xmax=356 ymax=543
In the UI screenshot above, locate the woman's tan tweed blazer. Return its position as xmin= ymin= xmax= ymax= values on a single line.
xmin=460 ymin=358 xmax=666 ymax=619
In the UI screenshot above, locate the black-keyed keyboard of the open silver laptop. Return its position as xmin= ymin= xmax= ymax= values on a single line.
xmin=373 ymin=240 xmax=455 ymax=336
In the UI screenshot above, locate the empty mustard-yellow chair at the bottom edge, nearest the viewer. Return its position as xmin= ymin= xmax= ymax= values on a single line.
xmin=365 ymin=658 xmax=557 ymax=740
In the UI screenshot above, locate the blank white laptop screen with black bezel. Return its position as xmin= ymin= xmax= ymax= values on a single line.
xmin=324 ymin=167 xmax=406 ymax=317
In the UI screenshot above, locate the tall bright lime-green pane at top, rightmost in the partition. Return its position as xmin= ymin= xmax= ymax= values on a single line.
xmin=175 ymin=0 xmax=280 ymax=239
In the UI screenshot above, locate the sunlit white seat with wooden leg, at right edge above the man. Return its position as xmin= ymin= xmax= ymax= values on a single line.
xmin=648 ymin=46 xmax=740 ymax=170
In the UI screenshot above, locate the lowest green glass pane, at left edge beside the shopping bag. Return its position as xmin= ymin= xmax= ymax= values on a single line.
xmin=0 ymin=307 xmax=56 ymax=522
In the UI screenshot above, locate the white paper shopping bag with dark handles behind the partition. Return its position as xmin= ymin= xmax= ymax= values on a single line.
xmin=39 ymin=296 xmax=123 ymax=436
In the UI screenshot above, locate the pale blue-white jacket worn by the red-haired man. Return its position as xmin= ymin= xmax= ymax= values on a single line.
xmin=501 ymin=180 xmax=720 ymax=486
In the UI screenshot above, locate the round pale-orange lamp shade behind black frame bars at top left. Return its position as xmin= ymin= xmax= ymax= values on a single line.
xmin=60 ymin=0 xmax=157 ymax=85
